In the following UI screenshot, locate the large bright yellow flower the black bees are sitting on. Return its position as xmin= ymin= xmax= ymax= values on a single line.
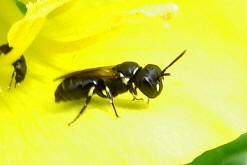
xmin=0 ymin=0 xmax=247 ymax=165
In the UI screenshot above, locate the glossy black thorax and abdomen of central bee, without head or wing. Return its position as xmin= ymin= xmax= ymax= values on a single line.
xmin=55 ymin=62 xmax=141 ymax=102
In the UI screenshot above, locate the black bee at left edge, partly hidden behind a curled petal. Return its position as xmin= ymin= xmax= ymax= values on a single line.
xmin=0 ymin=44 xmax=27 ymax=89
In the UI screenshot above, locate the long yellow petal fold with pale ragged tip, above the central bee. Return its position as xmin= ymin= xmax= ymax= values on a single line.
xmin=31 ymin=1 xmax=177 ymax=53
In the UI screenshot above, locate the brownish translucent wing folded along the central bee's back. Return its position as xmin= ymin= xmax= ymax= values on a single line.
xmin=54 ymin=66 xmax=120 ymax=81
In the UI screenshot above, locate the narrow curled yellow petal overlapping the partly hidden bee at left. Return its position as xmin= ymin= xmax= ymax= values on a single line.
xmin=0 ymin=0 xmax=75 ymax=65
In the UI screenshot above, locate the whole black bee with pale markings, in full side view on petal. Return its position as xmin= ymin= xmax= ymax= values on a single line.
xmin=55 ymin=50 xmax=186 ymax=125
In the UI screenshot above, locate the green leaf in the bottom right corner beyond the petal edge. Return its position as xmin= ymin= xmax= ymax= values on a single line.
xmin=188 ymin=133 xmax=247 ymax=165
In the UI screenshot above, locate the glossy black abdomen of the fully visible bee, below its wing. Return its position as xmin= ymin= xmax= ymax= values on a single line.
xmin=55 ymin=77 xmax=96 ymax=102
